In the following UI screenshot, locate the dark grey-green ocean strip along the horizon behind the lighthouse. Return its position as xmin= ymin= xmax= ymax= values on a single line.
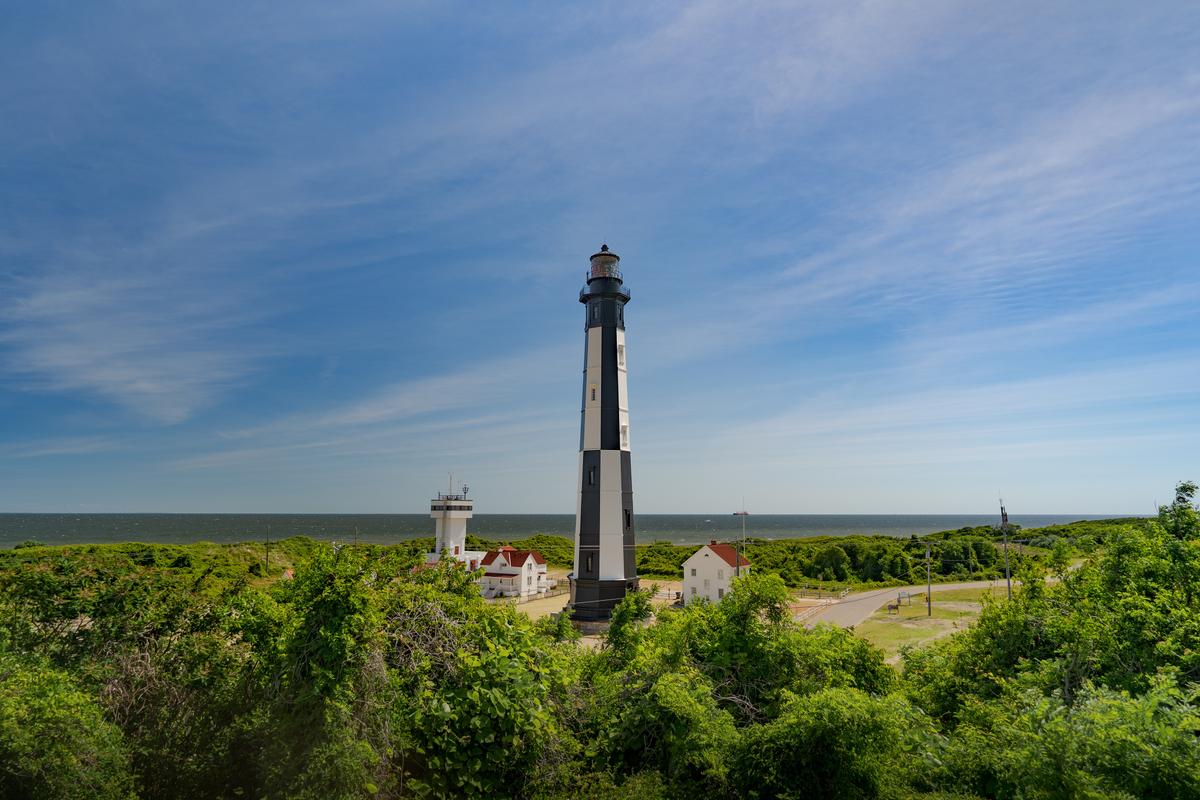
xmin=0 ymin=513 xmax=1123 ymax=548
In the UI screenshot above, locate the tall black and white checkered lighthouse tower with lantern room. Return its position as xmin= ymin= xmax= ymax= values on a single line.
xmin=570 ymin=245 xmax=637 ymax=620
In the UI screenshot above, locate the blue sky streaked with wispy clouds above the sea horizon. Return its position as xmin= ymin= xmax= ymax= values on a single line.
xmin=0 ymin=0 xmax=1200 ymax=513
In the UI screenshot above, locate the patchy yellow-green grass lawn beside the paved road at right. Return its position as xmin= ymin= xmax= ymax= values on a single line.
xmin=854 ymin=584 xmax=1006 ymax=663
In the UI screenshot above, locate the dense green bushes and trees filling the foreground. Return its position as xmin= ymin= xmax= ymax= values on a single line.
xmin=0 ymin=491 xmax=1200 ymax=800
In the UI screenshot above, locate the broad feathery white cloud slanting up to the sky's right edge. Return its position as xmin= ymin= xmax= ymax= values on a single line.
xmin=772 ymin=76 xmax=1200 ymax=311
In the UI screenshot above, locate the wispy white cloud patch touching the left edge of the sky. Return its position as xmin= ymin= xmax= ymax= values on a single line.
xmin=0 ymin=270 xmax=266 ymax=422
